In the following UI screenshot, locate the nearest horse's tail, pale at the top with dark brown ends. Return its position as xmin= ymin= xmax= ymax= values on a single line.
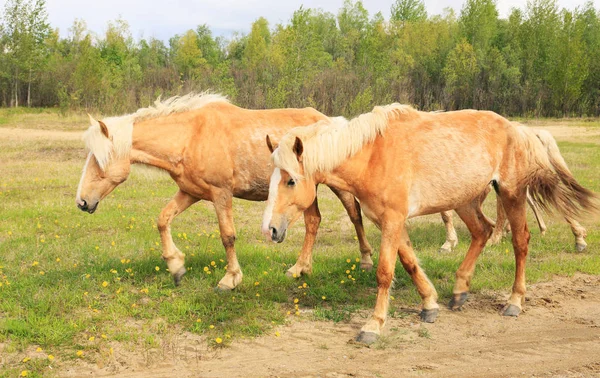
xmin=518 ymin=126 xmax=600 ymax=219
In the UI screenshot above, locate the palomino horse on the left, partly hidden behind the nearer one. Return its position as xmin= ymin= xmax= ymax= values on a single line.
xmin=76 ymin=94 xmax=373 ymax=290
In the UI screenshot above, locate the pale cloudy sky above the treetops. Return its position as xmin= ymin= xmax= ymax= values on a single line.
xmin=0 ymin=0 xmax=600 ymax=41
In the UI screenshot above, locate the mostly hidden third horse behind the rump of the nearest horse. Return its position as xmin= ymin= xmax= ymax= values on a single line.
xmin=440 ymin=127 xmax=587 ymax=252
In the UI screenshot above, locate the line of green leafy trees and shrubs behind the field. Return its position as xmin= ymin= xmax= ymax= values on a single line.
xmin=0 ymin=0 xmax=600 ymax=116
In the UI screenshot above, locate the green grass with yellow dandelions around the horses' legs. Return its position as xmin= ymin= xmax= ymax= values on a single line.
xmin=0 ymin=110 xmax=600 ymax=377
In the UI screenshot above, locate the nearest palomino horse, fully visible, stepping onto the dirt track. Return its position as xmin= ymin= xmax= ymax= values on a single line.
xmin=263 ymin=104 xmax=597 ymax=343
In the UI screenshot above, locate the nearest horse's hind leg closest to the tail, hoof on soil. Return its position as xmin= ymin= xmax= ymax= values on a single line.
xmin=501 ymin=191 xmax=530 ymax=316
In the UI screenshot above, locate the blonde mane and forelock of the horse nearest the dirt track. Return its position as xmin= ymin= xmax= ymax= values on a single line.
xmin=271 ymin=104 xmax=415 ymax=180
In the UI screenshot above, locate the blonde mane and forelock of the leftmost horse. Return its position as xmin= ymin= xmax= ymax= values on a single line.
xmin=83 ymin=92 xmax=229 ymax=170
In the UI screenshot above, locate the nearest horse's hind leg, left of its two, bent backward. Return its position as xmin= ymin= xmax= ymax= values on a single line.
xmin=449 ymin=200 xmax=494 ymax=310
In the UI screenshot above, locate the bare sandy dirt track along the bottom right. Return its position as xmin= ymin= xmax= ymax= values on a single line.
xmin=60 ymin=274 xmax=600 ymax=378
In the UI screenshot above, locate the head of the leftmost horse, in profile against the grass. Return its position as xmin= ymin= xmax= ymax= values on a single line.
xmin=75 ymin=116 xmax=131 ymax=214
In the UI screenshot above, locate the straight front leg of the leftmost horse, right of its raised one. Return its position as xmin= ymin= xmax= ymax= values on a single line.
xmin=213 ymin=190 xmax=243 ymax=290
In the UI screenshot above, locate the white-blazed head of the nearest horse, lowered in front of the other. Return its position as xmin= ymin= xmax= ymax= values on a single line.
xmin=262 ymin=136 xmax=317 ymax=243
